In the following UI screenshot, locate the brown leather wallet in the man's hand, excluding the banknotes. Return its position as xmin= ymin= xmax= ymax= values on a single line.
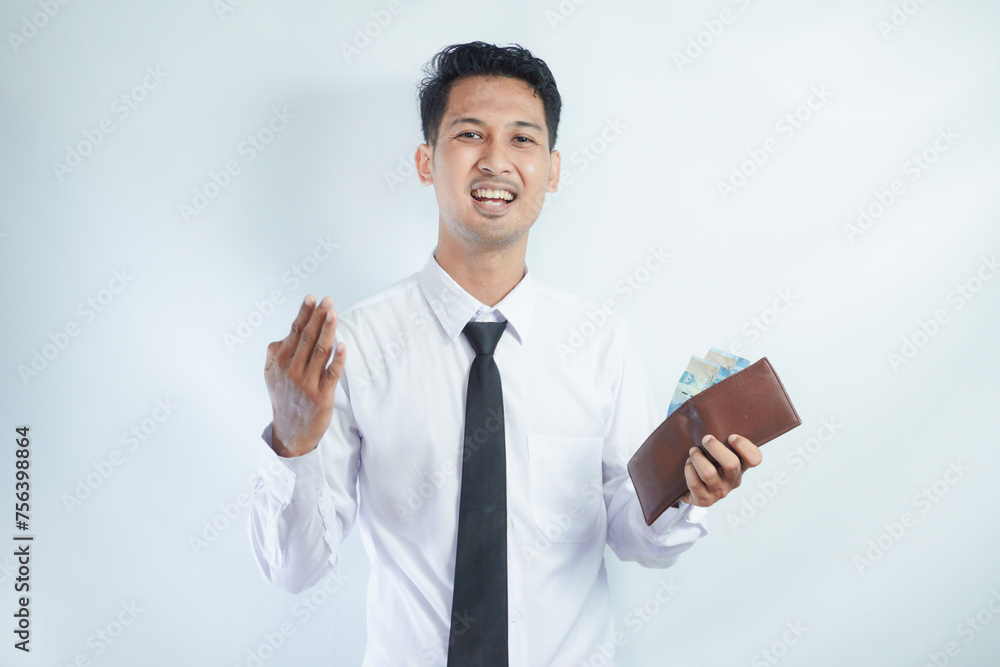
xmin=628 ymin=357 xmax=802 ymax=525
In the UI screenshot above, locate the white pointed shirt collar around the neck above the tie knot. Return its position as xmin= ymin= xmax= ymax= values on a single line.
xmin=420 ymin=246 xmax=535 ymax=345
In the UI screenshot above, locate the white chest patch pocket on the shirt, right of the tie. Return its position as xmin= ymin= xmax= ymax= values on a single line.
xmin=528 ymin=435 xmax=607 ymax=542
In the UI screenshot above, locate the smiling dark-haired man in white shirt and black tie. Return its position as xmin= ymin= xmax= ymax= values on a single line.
xmin=250 ymin=42 xmax=761 ymax=667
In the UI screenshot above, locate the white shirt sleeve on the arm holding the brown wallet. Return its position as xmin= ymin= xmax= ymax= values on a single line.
xmin=603 ymin=318 xmax=708 ymax=567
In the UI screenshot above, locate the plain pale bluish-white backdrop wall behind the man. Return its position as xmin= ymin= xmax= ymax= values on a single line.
xmin=0 ymin=0 xmax=1000 ymax=667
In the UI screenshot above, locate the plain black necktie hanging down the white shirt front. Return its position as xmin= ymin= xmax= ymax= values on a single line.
xmin=448 ymin=322 xmax=507 ymax=667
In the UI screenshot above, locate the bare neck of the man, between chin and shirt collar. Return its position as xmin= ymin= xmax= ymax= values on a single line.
xmin=434 ymin=234 xmax=528 ymax=307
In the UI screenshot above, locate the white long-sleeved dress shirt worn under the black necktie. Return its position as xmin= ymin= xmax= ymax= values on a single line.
xmin=249 ymin=248 xmax=706 ymax=667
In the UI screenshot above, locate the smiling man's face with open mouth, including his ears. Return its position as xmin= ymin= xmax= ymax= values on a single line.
xmin=416 ymin=76 xmax=560 ymax=246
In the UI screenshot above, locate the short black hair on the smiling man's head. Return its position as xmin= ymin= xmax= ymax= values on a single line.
xmin=419 ymin=42 xmax=562 ymax=150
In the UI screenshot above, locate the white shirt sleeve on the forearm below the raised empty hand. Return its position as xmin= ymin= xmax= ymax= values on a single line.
xmin=248 ymin=374 xmax=362 ymax=593
